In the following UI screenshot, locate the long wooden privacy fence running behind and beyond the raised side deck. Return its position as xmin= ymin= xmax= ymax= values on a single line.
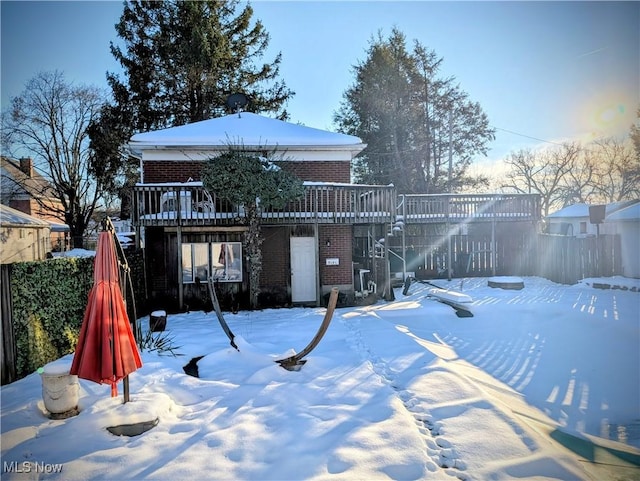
xmin=390 ymin=230 xmax=622 ymax=284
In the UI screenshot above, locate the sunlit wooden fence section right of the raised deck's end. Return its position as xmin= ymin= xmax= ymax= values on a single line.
xmin=536 ymin=234 xmax=622 ymax=284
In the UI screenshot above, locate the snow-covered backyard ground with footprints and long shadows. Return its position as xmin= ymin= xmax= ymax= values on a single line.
xmin=1 ymin=277 xmax=640 ymax=480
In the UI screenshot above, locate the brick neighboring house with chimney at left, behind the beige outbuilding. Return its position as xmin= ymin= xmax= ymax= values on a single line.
xmin=0 ymin=156 xmax=69 ymax=250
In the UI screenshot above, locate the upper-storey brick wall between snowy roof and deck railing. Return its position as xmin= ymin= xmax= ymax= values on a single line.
xmin=143 ymin=160 xmax=351 ymax=183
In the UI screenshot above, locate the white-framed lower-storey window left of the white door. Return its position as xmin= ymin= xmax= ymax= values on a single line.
xmin=182 ymin=242 xmax=242 ymax=284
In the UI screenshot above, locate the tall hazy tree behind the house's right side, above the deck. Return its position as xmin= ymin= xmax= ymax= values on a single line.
xmin=334 ymin=28 xmax=494 ymax=193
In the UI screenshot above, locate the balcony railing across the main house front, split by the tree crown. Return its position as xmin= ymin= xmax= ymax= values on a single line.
xmin=133 ymin=182 xmax=396 ymax=227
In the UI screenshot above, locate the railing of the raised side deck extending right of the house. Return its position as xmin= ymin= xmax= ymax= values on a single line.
xmin=397 ymin=194 xmax=541 ymax=224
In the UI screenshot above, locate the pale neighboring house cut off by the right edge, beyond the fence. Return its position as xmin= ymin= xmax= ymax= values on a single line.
xmin=602 ymin=201 xmax=640 ymax=278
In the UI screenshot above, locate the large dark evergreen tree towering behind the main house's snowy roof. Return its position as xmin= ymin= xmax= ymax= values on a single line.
xmin=90 ymin=0 xmax=293 ymax=204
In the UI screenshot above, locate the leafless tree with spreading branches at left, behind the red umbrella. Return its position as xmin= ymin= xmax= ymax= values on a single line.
xmin=2 ymin=71 xmax=105 ymax=247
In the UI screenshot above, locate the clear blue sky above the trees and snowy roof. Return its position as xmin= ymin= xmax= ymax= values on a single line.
xmin=0 ymin=0 xmax=640 ymax=161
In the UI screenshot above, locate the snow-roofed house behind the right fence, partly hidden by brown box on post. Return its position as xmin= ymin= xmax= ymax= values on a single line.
xmin=546 ymin=200 xmax=640 ymax=237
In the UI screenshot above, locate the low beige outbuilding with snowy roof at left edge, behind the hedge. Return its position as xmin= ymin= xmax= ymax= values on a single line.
xmin=0 ymin=204 xmax=51 ymax=264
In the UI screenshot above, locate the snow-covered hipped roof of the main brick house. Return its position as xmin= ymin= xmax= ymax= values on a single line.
xmin=129 ymin=112 xmax=365 ymax=152
